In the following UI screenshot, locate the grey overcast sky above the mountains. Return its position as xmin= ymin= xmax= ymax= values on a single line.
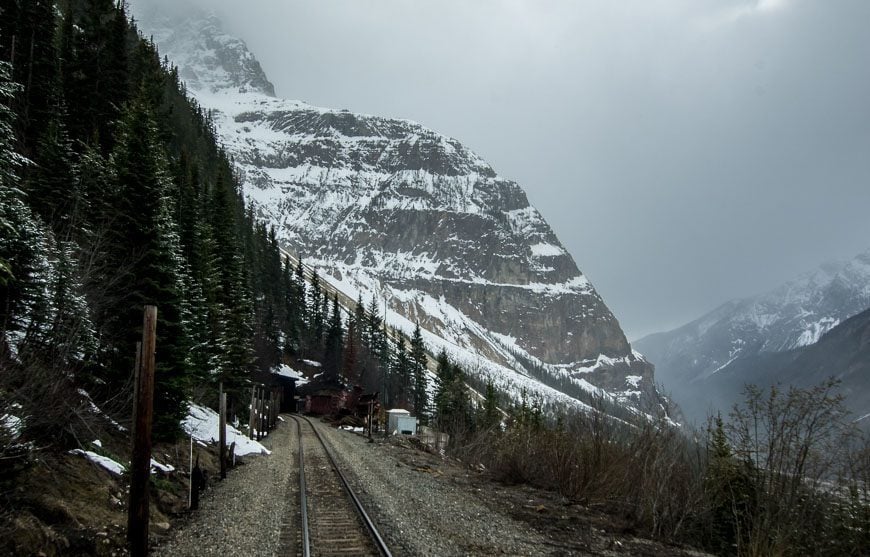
xmin=136 ymin=0 xmax=870 ymax=340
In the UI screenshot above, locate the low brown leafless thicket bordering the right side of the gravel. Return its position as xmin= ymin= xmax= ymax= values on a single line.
xmin=461 ymin=402 xmax=703 ymax=539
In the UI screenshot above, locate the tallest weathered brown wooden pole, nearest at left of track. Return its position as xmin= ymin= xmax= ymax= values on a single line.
xmin=127 ymin=306 xmax=157 ymax=557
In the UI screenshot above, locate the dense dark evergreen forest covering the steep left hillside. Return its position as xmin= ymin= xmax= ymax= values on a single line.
xmin=0 ymin=0 xmax=328 ymax=444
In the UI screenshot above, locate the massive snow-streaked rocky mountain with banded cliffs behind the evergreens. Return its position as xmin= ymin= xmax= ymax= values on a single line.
xmin=134 ymin=1 xmax=661 ymax=416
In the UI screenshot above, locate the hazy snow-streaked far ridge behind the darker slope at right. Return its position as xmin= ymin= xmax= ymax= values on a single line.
xmin=635 ymin=250 xmax=870 ymax=417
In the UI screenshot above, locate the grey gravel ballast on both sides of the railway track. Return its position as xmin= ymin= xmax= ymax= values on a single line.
xmin=154 ymin=416 xmax=702 ymax=557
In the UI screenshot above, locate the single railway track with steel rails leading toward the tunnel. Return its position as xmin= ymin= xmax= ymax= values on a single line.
xmin=293 ymin=416 xmax=392 ymax=557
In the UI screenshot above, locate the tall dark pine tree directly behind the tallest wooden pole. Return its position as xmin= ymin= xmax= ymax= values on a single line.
xmin=104 ymin=90 xmax=189 ymax=437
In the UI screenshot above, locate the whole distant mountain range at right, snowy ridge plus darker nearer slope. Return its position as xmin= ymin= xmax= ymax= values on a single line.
xmin=635 ymin=250 xmax=870 ymax=421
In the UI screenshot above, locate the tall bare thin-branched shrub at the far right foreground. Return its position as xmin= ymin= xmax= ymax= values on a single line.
xmin=726 ymin=380 xmax=866 ymax=555
